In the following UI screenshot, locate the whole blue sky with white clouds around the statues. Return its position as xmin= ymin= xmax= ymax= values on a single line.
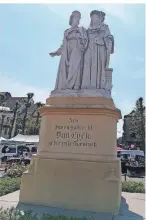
xmin=0 ymin=4 xmax=145 ymax=136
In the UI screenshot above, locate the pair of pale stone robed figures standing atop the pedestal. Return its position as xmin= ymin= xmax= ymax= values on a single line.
xmin=50 ymin=10 xmax=114 ymax=91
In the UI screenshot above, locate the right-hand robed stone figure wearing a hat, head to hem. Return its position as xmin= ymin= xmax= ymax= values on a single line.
xmin=82 ymin=10 xmax=114 ymax=89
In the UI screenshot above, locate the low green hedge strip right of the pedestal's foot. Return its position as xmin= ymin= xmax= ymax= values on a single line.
xmin=122 ymin=181 xmax=145 ymax=193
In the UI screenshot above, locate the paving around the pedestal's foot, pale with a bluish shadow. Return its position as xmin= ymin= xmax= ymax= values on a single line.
xmin=0 ymin=191 xmax=145 ymax=220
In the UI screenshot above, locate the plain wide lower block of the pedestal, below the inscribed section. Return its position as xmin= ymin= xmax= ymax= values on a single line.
xmin=20 ymin=157 xmax=121 ymax=213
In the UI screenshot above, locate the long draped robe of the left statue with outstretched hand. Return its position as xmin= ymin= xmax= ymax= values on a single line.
xmin=55 ymin=27 xmax=88 ymax=90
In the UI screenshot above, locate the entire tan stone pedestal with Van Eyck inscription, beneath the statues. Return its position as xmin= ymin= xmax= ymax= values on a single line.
xmin=20 ymin=97 xmax=121 ymax=213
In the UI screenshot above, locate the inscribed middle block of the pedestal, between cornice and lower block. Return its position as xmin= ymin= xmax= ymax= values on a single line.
xmin=38 ymin=112 xmax=116 ymax=159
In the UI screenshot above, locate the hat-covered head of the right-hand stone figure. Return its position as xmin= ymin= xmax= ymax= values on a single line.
xmin=90 ymin=10 xmax=105 ymax=26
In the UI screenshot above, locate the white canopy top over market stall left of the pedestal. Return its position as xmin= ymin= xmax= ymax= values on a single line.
xmin=2 ymin=134 xmax=39 ymax=143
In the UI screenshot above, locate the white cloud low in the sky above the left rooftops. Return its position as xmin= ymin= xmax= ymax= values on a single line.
xmin=0 ymin=73 xmax=51 ymax=102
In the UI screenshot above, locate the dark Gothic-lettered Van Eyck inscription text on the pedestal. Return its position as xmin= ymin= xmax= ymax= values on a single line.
xmin=48 ymin=118 xmax=97 ymax=147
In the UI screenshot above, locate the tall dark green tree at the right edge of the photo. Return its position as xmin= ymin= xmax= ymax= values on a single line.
xmin=130 ymin=97 xmax=145 ymax=152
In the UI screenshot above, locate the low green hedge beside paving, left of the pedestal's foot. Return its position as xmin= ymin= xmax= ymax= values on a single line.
xmin=0 ymin=177 xmax=21 ymax=196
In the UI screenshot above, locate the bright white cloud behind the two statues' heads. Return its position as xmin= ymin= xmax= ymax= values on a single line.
xmin=47 ymin=3 xmax=133 ymax=27
